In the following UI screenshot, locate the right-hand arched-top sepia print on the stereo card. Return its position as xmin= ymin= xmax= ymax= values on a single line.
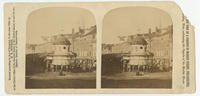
xmin=101 ymin=7 xmax=173 ymax=89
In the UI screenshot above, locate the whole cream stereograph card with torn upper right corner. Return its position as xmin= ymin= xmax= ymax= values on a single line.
xmin=4 ymin=2 xmax=195 ymax=94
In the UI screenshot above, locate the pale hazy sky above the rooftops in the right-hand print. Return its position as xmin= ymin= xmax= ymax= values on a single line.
xmin=102 ymin=7 xmax=172 ymax=44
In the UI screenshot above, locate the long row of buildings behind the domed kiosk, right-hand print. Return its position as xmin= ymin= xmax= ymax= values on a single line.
xmin=102 ymin=26 xmax=173 ymax=71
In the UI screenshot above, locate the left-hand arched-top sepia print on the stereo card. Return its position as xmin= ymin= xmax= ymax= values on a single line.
xmin=25 ymin=7 xmax=97 ymax=89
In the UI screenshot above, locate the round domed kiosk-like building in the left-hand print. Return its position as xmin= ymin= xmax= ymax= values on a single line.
xmin=46 ymin=35 xmax=76 ymax=72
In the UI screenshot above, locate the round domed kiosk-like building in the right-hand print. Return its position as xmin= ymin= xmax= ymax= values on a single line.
xmin=123 ymin=36 xmax=153 ymax=72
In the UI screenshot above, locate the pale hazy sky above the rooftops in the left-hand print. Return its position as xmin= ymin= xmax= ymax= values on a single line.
xmin=26 ymin=7 xmax=96 ymax=44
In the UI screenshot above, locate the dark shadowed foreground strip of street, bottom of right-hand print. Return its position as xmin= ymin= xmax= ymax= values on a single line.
xmin=102 ymin=79 xmax=172 ymax=88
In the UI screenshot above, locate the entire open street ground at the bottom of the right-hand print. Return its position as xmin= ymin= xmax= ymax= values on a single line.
xmin=101 ymin=72 xmax=172 ymax=88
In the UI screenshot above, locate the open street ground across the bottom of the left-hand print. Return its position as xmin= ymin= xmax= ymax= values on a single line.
xmin=25 ymin=72 xmax=96 ymax=89
